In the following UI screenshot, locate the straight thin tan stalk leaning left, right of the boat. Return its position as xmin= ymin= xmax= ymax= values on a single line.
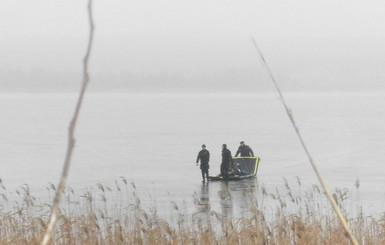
xmin=251 ymin=38 xmax=358 ymax=245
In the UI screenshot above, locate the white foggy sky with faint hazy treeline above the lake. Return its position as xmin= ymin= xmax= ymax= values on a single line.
xmin=0 ymin=0 xmax=385 ymax=92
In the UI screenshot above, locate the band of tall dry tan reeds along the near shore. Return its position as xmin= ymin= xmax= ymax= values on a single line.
xmin=0 ymin=178 xmax=385 ymax=245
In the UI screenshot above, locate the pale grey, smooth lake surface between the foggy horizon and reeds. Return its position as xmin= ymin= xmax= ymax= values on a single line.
xmin=0 ymin=93 xmax=385 ymax=220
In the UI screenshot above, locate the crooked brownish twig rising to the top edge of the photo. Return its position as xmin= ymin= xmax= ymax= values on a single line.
xmin=41 ymin=0 xmax=94 ymax=245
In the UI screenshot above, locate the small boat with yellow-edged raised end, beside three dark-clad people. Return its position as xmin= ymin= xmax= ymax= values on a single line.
xmin=208 ymin=157 xmax=260 ymax=180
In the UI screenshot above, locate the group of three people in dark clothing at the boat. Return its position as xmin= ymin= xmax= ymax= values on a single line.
xmin=196 ymin=141 xmax=254 ymax=182
